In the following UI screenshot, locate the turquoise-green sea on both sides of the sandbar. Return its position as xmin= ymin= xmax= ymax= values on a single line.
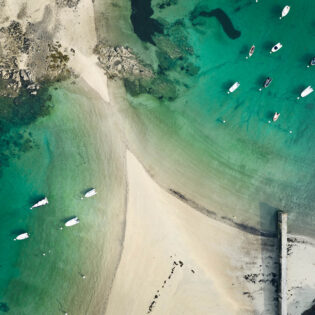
xmin=0 ymin=0 xmax=315 ymax=315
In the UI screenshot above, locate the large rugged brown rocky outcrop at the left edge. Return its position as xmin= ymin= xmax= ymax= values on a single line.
xmin=0 ymin=21 xmax=70 ymax=97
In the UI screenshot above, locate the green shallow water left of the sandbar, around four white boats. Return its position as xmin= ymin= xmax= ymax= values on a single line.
xmin=0 ymin=85 xmax=124 ymax=315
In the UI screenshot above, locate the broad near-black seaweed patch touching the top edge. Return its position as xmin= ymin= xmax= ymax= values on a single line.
xmin=130 ymin=0 xmax=163 ymax=45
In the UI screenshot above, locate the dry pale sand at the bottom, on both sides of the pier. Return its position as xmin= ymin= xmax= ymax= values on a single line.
xmin=106 ymin=152 xmax=315 ymax=315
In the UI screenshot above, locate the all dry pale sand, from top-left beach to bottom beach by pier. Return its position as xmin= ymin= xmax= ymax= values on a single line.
xmin=0 ymin=0 xmax=315 ymax=315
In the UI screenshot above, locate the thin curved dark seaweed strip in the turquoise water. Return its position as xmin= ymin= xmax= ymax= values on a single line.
xmin=190 ymin=8 xmax=241 ymax=39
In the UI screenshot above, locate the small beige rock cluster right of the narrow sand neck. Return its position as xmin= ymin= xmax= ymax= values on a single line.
xmin=94 ymin=43 xmax=153 ymax=79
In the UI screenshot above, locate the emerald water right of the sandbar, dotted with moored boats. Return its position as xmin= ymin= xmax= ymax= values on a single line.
xmin=104 ymin=0 xmax=315 ymax=235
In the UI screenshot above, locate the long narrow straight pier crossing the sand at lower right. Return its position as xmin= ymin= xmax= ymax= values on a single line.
xmin=278 ymin=211 xmax=288 ymax=315
